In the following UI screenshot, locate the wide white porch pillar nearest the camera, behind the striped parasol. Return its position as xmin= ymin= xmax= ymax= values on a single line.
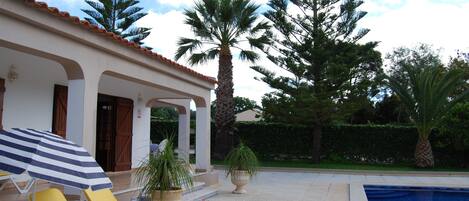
xmin=66 ymin=76 xmax=99 ymax=157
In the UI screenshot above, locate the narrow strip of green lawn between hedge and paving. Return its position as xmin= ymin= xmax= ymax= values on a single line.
xmin=212 ymin=160 xmax=469 ymax=172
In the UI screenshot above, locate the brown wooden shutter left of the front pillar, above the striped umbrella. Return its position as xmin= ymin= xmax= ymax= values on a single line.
xmin=52 ymin=85 xmax=68 ymax=138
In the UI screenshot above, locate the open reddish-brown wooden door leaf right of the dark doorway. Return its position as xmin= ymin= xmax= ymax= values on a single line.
xmin=114 ymin=98 xmax=133 ymax=171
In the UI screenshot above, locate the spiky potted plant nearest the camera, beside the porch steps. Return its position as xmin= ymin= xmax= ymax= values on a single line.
xmin=137 ymin=140 xmax=193 ymax=201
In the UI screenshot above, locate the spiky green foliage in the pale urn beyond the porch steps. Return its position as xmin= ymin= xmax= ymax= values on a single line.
xmin=225 ymin=143 xmax=259 ymax=176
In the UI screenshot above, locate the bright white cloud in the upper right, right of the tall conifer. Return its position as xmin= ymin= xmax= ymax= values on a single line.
xmin=360 ymin=0 xmax=469 ymax=58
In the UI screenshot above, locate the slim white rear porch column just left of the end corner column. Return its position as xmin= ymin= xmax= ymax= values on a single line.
xmin=178 ymin=108 xmax=190 ymax=162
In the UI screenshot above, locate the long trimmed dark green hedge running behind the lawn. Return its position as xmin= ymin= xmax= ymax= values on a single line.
xmin=151 ymin=121 xmax=458 ymax=165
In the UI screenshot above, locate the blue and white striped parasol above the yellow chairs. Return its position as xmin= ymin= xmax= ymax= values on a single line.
xmin=0 ymin=128 xmax=112 ymax=190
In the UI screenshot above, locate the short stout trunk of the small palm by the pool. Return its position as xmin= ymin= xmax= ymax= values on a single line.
xmin=415 ymin=137 xmax=435 ymax=168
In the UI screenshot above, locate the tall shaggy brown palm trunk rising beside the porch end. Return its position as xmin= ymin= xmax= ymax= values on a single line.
xmin=213 ymin=48 xmax=235 ymax=160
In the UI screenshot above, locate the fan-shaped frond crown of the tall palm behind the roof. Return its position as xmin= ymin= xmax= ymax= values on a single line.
xmin=175 ymin=0 xmax=270 ymax=64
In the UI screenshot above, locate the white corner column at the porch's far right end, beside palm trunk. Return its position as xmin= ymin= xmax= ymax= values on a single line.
xmin=195 ymin=105 xmax=210 ymax=170
